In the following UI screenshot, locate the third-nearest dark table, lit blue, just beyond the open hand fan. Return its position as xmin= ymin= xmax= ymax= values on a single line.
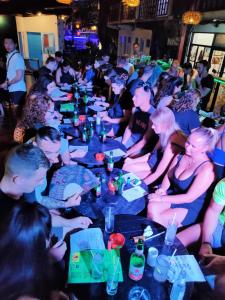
xmin=70 ymin=135 xmax=127 ymax=168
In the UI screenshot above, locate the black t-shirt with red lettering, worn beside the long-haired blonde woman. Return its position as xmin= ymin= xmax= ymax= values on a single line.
xmin=131 ymin=106 xmax=155 ymax=135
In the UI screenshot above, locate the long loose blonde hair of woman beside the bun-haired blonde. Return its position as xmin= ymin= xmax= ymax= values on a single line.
xmin=150 ymin=107 xmax=180 ymax=148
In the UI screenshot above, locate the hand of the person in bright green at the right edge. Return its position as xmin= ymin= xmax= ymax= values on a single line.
xmin=204 ymin=254 xmax=225 ymax=274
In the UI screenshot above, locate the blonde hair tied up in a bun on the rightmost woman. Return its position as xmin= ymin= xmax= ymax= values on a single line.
xmin=191 ymin=127 xmax=219 ymax=152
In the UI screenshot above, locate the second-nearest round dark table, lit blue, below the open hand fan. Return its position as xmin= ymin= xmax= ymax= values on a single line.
xmin=76 ymin=168 xmax=148 ymax=219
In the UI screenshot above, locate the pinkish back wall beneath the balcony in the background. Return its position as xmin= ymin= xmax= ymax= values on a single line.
xmin=118 ymin=26 xmax=152 ymax=56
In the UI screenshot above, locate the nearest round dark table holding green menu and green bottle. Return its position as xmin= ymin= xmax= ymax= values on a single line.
xmin=70 ymin=215 xmax=194 ymax=300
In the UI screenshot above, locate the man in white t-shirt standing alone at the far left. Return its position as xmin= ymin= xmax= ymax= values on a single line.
xmin=0 ymin=36 xmax=26 ymax=113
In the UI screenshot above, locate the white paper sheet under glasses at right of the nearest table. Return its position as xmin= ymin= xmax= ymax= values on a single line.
xmin=172 ymin=255 xmax=205 ymax=282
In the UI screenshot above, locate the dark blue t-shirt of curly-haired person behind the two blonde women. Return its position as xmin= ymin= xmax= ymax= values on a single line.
xmin=173 ymin=110 xmax=200 ymax=135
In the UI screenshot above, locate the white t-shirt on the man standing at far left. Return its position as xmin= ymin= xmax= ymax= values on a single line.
xmin=6 ymin=50 xmax=26 ymax=92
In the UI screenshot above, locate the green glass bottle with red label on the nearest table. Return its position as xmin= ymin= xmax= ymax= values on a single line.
xmin=129 ymin=239 xmax=145 ymax=281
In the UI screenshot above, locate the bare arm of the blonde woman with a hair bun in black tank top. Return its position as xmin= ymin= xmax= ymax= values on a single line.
xmin=162 ymin=164 xmax=215 ymax=204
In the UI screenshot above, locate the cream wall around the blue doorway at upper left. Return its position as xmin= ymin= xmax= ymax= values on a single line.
xmin=16 ymin=15 xmax=59 ymax=62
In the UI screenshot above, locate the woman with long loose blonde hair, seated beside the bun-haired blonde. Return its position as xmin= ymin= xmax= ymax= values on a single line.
xmin=123 ymin=107 xmax=185 ymax=184
